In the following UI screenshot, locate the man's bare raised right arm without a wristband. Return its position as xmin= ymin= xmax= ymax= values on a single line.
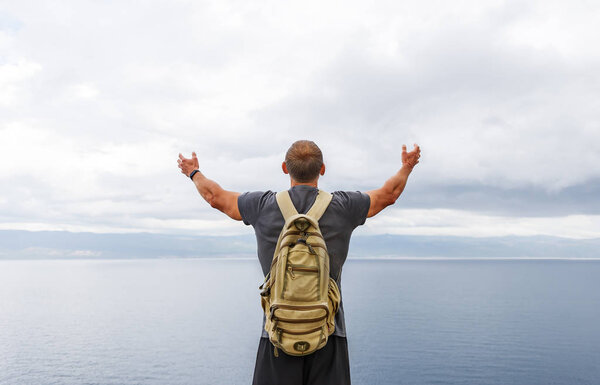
xmin=367 ymin=144 xmax=421 ymax=218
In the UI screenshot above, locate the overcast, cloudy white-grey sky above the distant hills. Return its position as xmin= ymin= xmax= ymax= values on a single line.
xmin=0 ymin=0 xmax=600 ymax=239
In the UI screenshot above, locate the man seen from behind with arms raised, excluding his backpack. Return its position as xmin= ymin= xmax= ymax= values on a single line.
xmin=177 ymin=140 xmax=421 ymax=385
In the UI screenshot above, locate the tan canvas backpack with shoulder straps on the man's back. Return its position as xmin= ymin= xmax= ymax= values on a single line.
xmin=260 ymin=190 xmax=340 ymax=357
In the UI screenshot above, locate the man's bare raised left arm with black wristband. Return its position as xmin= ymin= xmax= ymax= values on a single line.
xmin=177 ymin=152 xmax=242 ymax=221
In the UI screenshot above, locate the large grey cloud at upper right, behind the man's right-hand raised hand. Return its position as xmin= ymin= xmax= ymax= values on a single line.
xmin=259 ymin=6 xmax=600 ymax=191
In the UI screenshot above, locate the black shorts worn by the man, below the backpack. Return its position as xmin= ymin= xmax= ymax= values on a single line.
xmin=252 ymin=336 xmax=350 ymax=385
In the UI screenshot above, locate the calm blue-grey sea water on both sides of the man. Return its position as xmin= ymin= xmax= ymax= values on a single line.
xmin=0 ymin=259 xmax=600 ymax=385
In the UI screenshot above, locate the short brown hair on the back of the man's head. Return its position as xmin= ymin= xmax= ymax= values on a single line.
xmin=285 ymin=140 xmax=323 ymax=183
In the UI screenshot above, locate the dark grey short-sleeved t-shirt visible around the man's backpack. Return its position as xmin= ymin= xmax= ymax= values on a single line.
xmin=238 ymin=185 xmax=371 ymax=337
